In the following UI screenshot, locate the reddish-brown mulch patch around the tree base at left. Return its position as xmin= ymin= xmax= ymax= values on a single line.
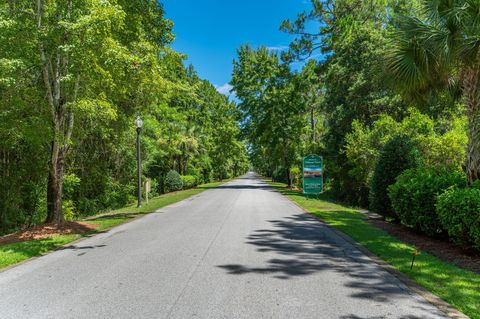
xmin=0 ymin=222 xmax=97 ymax=245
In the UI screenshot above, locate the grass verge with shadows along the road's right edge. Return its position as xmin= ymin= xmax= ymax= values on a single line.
xmin=271 ymin=183 xmax=480 ymax=319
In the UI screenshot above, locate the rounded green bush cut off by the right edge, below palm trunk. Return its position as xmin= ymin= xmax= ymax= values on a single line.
xmin=436 ymin=188 xmax=480 ymax=249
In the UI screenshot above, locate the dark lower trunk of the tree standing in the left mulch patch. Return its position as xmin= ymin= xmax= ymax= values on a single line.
xmin=45 ymin=142 xmax=64 ymax=224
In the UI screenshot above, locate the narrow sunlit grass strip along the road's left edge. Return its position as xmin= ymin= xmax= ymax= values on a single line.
xmin=0 ymin=181 xmax=225 ymax=269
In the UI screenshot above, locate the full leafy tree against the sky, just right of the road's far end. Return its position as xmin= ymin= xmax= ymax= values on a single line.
xmin=231 ymin=45 xmax=306 ymax=186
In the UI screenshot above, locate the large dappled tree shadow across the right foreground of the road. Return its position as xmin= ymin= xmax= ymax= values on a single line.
xmin=218 ymin=213 xmax=442 ymax=319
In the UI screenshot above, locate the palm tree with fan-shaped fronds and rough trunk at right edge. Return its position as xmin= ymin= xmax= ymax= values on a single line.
xmin=389 ymin=0 xmax=480 ymax=184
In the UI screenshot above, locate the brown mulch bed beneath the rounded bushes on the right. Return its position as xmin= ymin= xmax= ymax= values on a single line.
xmin=368 ymin=218 xmax=480 ymax=274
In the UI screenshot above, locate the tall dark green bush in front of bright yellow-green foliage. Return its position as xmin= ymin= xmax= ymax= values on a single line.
xmin=369 ymin=136 xmax=419 ymax=219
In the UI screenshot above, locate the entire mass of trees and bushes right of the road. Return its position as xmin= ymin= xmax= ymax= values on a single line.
xmin=231 ymin=0 xmax=480 ymax=258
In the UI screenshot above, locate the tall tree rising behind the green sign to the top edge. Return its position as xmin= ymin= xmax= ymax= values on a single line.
xmin=281 ymin=0 xmax=410 ymax=203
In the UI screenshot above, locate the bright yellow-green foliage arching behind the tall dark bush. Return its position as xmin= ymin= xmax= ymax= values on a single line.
xmin=345 ymin=109 xmax=467 ymax=205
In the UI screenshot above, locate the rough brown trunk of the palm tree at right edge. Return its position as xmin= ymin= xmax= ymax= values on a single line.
xmin=463 ymin=68 xmax=480 ymax=185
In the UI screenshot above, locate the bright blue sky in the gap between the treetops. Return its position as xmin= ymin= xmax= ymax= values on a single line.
xmin=161 ymin=0 xmax=310 ymax=92
